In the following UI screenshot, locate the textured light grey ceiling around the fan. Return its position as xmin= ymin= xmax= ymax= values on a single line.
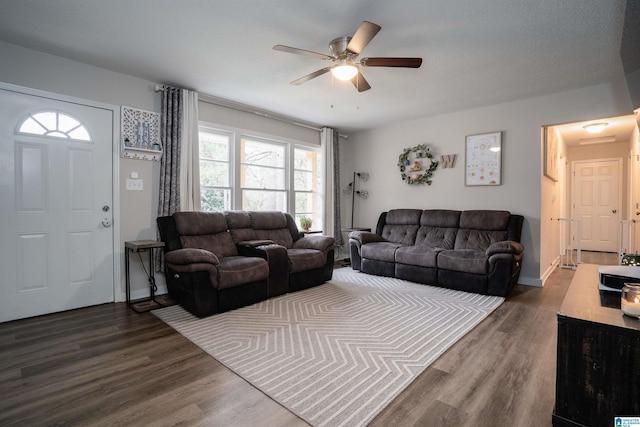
xmin=0 ymin=0 xmax=625 ymax=131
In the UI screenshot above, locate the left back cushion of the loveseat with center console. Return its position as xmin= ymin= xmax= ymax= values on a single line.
xmin=173 ymin=212 xmax=238 ymax=258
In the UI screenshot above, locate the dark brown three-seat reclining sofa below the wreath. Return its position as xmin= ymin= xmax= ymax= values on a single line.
xmin=349 ymin=209 xmax=524 ymax=296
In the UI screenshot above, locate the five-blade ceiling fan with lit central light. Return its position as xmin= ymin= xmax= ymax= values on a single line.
xmin=273 ymin=21 xmax=422 ymax=92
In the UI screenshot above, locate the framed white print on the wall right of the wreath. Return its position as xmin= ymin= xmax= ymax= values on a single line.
xmin=464 ymin=132 xmax=502 ymax=186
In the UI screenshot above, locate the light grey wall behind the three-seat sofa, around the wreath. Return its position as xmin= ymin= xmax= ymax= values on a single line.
xmin=342 ymin=80 xmax=631 ymax=285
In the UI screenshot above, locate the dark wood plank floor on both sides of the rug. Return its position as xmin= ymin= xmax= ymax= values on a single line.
xmin=0 ymin=253 xmax=617 ymax=426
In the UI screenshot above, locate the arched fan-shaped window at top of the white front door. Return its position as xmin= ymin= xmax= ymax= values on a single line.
xmin=18 ymin=111 xmax=91 ymax=142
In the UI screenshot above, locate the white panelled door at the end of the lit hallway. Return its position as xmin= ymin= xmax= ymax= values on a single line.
xmin=571 ymin=159 xmax=622 ymax=252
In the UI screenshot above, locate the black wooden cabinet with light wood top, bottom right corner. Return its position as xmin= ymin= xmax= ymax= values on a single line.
xmin=553 ymin=264 xmax=640 ymax=426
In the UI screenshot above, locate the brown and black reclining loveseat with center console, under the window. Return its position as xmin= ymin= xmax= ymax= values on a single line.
xmin=157 ymin=211 xmax=335 ymax=317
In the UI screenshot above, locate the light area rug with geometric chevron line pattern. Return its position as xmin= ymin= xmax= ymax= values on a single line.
xmin=153 ymin=268 xmax=504 ymax=426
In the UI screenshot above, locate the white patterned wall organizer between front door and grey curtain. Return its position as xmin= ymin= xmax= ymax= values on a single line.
xmin=121 ymin=106 xmax=162 ymax=161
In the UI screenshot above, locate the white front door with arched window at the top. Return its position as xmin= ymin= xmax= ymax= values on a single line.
xmin=0 ymin=88 xmax=114 ymax=322
